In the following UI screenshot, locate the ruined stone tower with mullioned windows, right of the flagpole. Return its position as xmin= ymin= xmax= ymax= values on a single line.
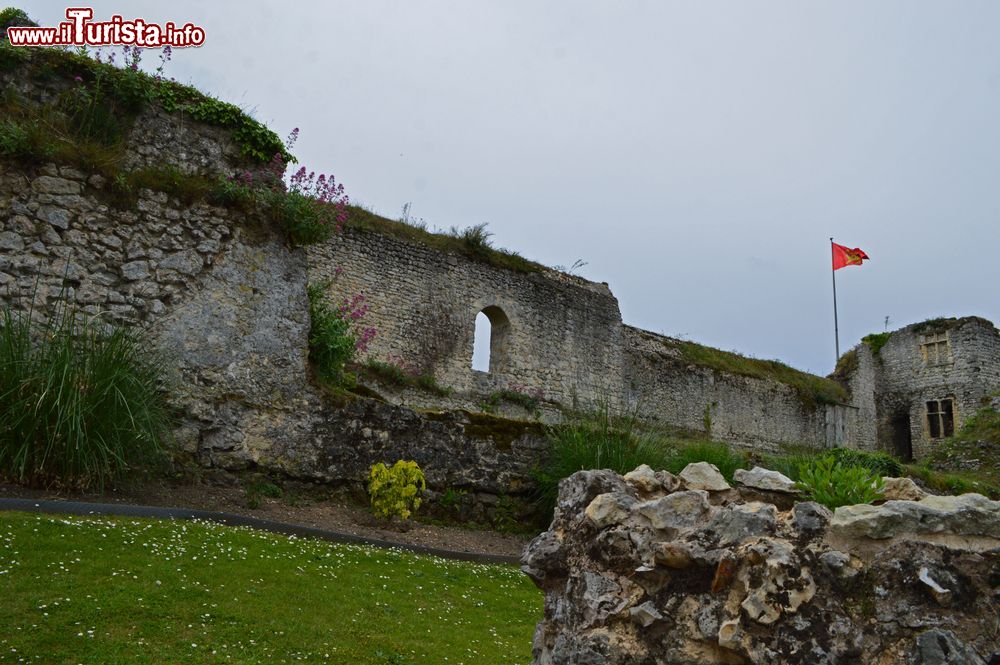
xmin=860 ymin=317 xmax=1000 ymax=459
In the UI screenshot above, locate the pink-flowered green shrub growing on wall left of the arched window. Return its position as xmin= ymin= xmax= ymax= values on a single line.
xmin=306 ymin=281 xmax=375 ymax=385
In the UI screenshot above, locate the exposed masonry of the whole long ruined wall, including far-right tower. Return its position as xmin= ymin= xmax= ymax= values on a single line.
xmin=0 ymin=59 xmax=1000 ymax=508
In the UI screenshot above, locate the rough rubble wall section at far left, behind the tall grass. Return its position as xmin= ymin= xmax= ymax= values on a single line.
xmin=0 ymin=159 xmax=309 ymax=466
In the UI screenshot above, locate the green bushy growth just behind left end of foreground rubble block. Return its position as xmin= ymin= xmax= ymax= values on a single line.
xmin=534 ymin=408 xmax=672 ymax=515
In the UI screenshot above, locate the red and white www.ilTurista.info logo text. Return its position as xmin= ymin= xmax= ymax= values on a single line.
xmin=7 ymin=7 xmax=205 ymax=48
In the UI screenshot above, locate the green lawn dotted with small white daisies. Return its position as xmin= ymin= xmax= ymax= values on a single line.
xmin=0 ymin=512 xmax=542 ymax=665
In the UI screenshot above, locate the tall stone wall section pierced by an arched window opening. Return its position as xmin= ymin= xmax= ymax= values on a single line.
xmin=309 ymin=230 xmax=623 ymax=408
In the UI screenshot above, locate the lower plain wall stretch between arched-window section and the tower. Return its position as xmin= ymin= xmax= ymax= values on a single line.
xmin=624 ymin=326 xmax=853 ymax=452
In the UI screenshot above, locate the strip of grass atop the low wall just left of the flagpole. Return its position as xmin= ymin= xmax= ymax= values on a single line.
xmin=663 ymin=339 xmax=848 ymax=404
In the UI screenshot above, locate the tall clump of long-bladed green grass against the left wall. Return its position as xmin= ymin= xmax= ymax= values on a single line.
xmin=0 ymin=307 xmax=169 ymax=487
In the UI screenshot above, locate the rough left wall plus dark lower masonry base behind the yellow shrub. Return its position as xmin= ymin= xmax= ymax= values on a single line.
xmin=0 ymin=156 xmax=545 ymax=521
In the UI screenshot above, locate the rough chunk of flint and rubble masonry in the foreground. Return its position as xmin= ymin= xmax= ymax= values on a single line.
xmin=523 ymin=467 xmax=1000 ymax=665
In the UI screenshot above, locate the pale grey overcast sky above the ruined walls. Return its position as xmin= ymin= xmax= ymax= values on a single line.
xmin=20 ymin=0 xmax=1000 ymax=374
